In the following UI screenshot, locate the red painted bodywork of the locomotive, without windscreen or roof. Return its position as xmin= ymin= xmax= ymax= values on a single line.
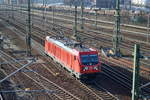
xmin=45 ymin=37 xmax=101 ymax=74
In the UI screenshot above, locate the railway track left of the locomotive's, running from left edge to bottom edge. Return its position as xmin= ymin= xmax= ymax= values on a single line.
xmin=1 ymin=51 xmax=80 ymax=100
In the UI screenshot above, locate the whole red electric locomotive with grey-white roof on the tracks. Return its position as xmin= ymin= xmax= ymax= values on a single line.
xmin=45 ymin=36 xmax=101 ymax=78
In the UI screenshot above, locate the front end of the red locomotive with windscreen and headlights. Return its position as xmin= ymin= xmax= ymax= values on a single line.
xmin=80 ymin=53 xmax=100 ymax=73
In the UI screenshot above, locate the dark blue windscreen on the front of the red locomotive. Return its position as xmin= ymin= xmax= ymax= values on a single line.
xmin=80 ymin=54 xmax=99 ymax=66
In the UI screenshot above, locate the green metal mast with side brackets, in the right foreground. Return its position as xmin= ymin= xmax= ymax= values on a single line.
xmin=132 ymin=44 xmax=150 ymax=100
